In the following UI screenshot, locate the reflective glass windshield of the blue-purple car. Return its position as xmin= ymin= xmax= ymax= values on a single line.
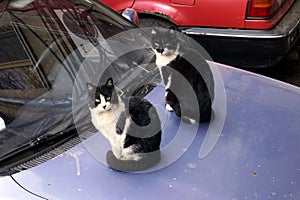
xmin=0 ymin=0 xmax=157 ymax=160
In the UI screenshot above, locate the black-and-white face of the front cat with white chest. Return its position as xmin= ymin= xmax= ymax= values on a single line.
xmin=87 ymin=78 xmax=117 ymax=112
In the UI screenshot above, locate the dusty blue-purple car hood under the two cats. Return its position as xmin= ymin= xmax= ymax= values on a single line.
xmin=0 ymin=65 xmax=300 ymax=200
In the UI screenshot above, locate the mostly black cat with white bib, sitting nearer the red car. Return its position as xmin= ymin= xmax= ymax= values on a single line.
xmin=151 ymin=28 xmax=214 ymax=124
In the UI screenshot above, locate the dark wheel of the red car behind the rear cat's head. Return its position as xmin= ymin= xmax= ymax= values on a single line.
xmin=139 ymin=17 xmax=177 ymax=29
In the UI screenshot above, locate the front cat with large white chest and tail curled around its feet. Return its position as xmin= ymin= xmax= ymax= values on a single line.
xmin=87 ymin=78 xmax=161 ymax=171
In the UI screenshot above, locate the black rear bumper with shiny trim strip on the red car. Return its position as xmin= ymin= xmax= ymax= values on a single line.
xmin=180 ymin=1 xmax=300 ymax=67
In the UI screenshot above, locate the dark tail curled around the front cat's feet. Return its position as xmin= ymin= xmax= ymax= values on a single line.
xmin=106 ymin=150 xmax=161 ymax=172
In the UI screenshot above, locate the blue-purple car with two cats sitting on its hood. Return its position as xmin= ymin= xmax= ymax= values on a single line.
xmin=0 ymin=0 xmax=300 ymax=200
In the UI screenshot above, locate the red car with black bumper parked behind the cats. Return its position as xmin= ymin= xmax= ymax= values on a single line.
xmin=102 ymin=0 xmax=300 ymax=67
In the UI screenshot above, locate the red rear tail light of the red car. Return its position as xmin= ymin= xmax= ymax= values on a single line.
xmin=247 ymin=0 xmax=283 ymax=18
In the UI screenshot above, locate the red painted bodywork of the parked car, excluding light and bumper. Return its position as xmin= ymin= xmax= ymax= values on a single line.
xmin=102 ymin=0 xmax=295 ymax=29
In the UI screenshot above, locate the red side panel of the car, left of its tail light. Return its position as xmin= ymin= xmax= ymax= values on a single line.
xmin=102 ymin=0 xmax=247 ymax=28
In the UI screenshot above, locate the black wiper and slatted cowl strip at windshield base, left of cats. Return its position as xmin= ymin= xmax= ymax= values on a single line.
xmin=0 ymin=118 xmax=95 ymax=176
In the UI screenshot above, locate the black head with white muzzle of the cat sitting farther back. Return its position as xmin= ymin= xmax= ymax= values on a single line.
xmin=151 ymin=28 xmax=179 ymax=56
